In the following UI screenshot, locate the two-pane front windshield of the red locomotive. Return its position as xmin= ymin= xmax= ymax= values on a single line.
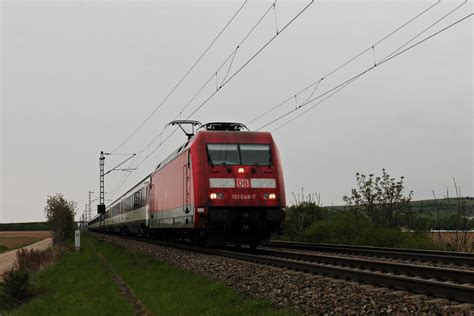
xmin=207 ymin=144 xmax=272 ymax=166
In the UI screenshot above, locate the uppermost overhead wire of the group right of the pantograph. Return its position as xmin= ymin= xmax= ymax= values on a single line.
xmin=245 ymin=0 xmax=441 ymax=126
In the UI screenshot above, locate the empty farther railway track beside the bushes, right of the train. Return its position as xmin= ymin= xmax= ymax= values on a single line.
xmin=268 ymin=241 xmax=474 ymax=266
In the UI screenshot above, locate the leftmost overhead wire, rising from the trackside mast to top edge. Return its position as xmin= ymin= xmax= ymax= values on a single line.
xmin=112 ymin=0 xmax=248 ymax=152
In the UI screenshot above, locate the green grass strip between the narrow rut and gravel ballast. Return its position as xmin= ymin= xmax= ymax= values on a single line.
xmin=86 ymin=237 xmax=295 ymax=315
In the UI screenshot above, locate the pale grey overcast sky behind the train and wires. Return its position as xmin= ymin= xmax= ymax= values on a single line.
xmin=0 ymin=1 xmax=474 ymax=222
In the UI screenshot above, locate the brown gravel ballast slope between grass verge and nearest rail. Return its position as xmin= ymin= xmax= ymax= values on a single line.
xmin=96 ymin=236 xmax=474 ymax=315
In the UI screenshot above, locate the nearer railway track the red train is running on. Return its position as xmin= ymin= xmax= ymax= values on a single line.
xmin=95 ymin=236 xmax=474 ymax=304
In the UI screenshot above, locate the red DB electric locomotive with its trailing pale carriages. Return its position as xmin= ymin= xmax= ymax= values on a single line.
xmin=89 ymin=121 xmax=286 ymax=246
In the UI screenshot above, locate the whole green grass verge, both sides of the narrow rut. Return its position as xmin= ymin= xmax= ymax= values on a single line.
xmin=6 ymin=235 xmax=296 ymax=315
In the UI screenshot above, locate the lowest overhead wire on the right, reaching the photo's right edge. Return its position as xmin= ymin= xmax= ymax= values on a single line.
xmin=257 ymin=13 xmax=473 ymax=131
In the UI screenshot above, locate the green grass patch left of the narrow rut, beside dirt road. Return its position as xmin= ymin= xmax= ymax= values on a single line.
xmin=11 ymin=243 xmax=133 ymax=315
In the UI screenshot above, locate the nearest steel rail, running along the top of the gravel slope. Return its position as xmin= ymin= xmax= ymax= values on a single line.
xmin=93 ymin=235 xmax=474 ymax=304
